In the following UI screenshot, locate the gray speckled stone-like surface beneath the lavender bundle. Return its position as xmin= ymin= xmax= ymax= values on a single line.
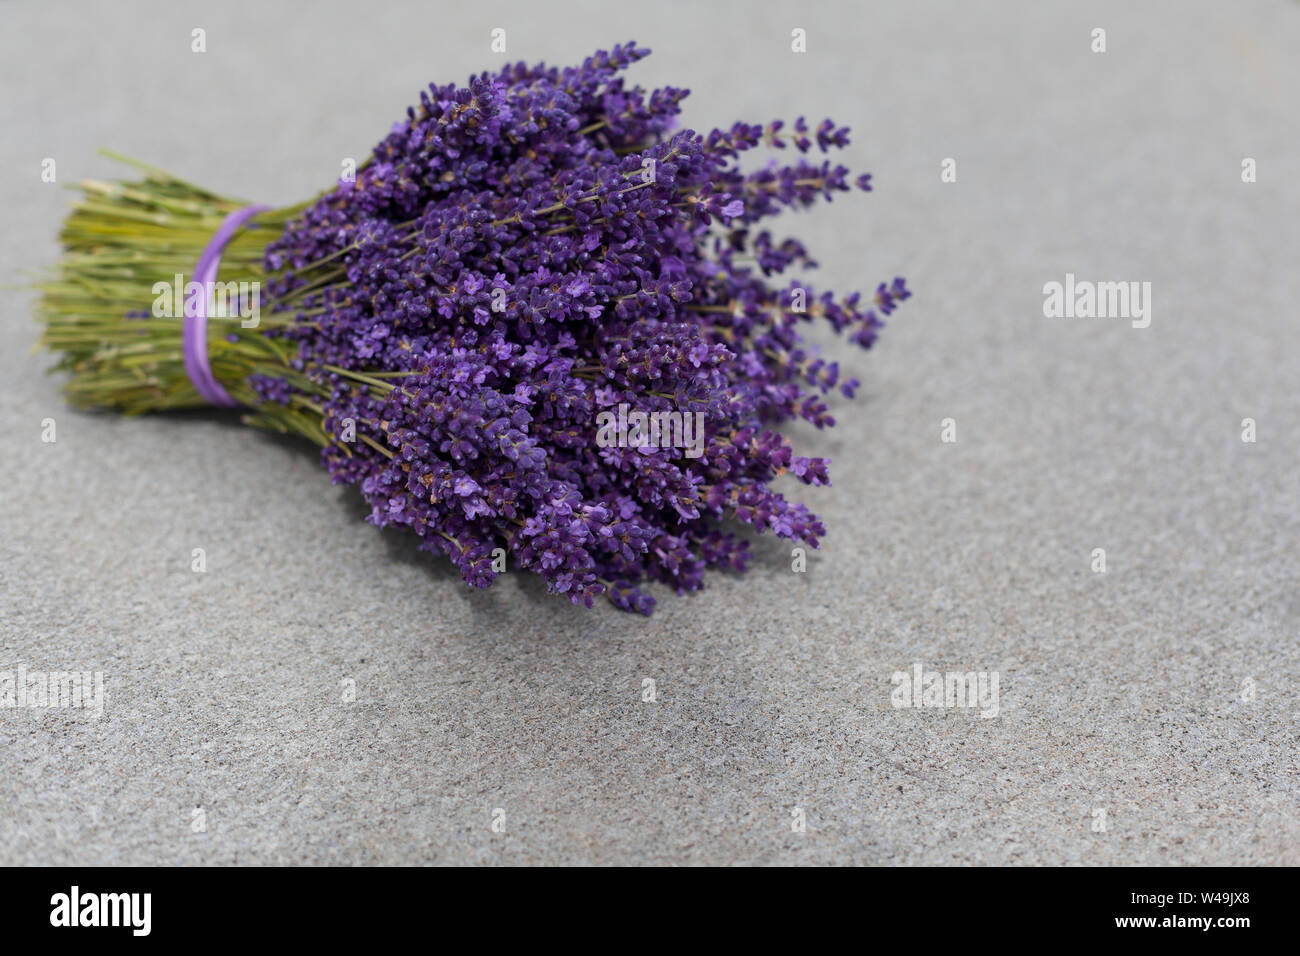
xmin=0 ymin=0 xmax=1300 ymax=864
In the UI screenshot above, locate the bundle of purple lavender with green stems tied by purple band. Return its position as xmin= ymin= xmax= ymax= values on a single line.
xmin=42 ymin=44 xmax=909 ymax=614
